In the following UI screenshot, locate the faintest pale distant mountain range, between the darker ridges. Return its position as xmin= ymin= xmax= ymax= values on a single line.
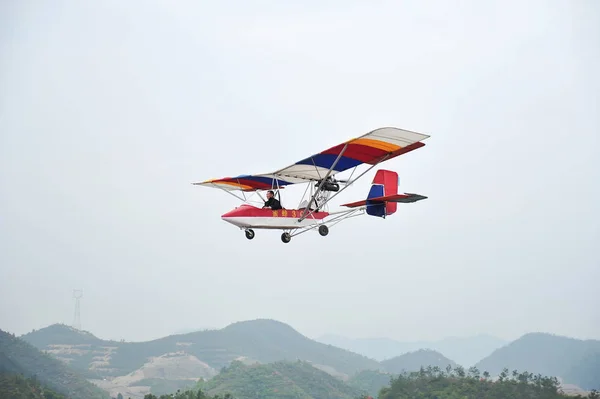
xmin=317 ymin=334 xmax=507 ymax=367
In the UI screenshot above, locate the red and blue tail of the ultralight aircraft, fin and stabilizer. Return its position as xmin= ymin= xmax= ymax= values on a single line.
xmin=342 ymin=169 xmax=427 ymax=218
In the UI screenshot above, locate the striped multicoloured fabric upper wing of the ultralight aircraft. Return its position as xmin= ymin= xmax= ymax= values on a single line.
xmin=194 ymin=127 xmax=429 ymax=191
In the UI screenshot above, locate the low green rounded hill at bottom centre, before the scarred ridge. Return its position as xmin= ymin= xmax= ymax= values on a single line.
xmin=198 ymin=360 xmax=363 ymax=399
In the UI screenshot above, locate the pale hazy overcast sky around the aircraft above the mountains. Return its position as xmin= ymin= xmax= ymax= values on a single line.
xmin=0 ymin=0 xmax=600 ymax=340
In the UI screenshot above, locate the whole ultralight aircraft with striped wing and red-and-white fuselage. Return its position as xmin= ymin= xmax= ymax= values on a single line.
xmin=192 ymin=127 xmax=430 ymax=243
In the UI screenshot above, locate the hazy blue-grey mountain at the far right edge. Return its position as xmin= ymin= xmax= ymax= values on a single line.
xmin=476 ymin=333 xmax=600 ymax=390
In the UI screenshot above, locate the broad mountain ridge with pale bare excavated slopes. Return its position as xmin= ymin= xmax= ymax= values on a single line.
xmin=22 ymin=319 xmax=381 ymax=398
